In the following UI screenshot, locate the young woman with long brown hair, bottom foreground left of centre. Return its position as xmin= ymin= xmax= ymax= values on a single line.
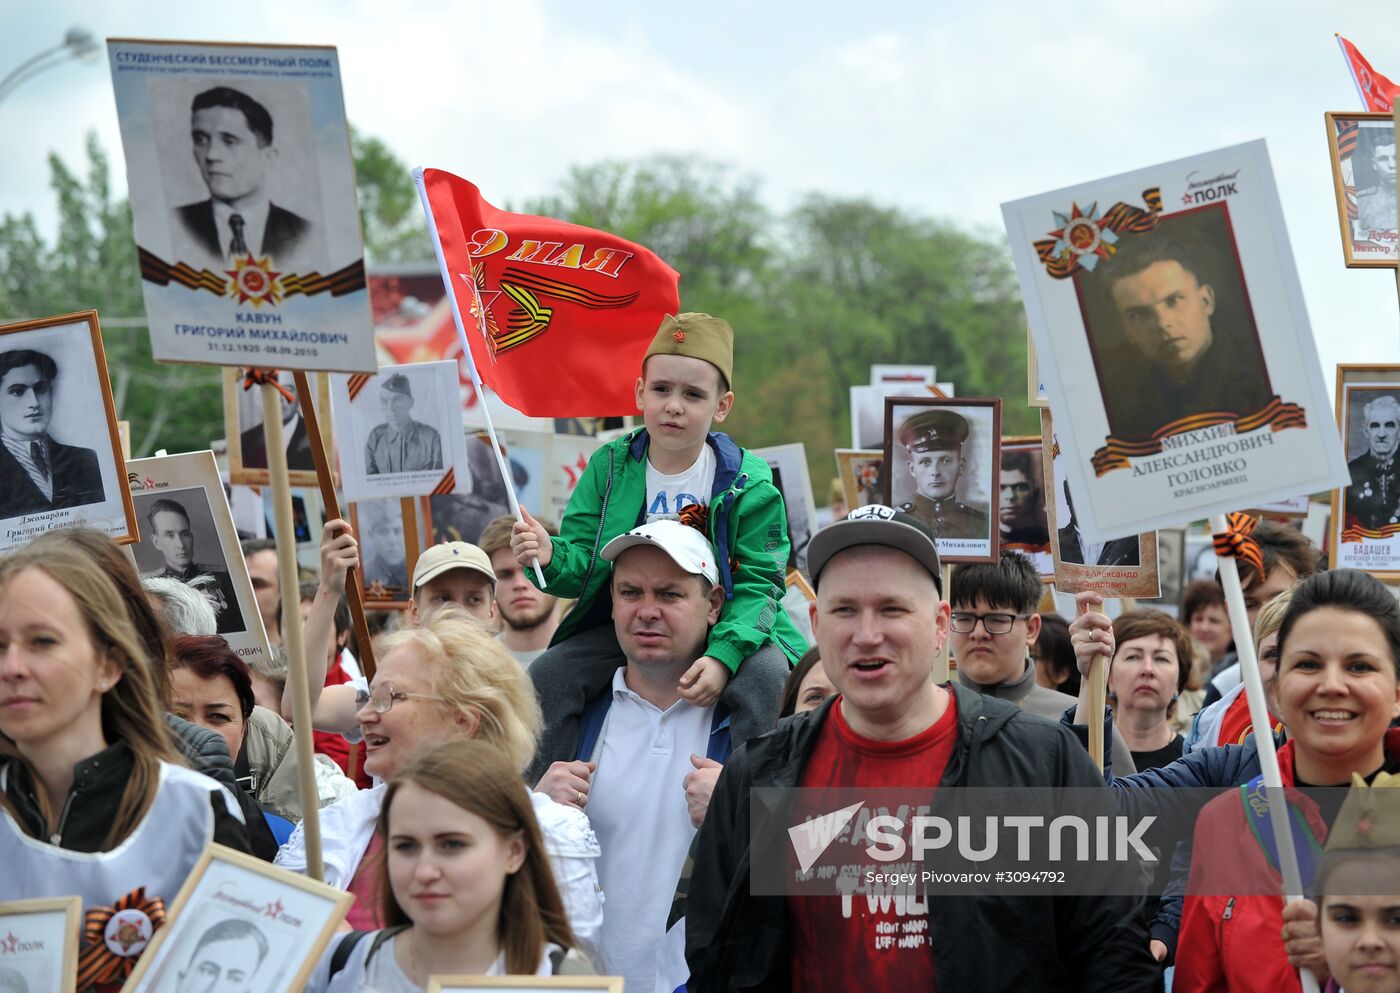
xmin=307 ymin=738 xmax=580 ymax=993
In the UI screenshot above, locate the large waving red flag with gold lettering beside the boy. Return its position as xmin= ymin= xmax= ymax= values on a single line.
xmin=423 ymin=169 xmax=680 ymax=417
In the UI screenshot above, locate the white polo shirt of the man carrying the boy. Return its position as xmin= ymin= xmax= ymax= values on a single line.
xmin=584 ymin=668 xmax=714 ymax=993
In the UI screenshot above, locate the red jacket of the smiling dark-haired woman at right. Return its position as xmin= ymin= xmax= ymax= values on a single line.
xmin=1172 ymin=728 xmax=1400 ymax=993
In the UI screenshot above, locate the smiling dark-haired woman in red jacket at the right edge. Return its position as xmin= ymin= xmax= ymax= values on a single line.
xmin=1072 ymin=570 xmax=1400 ymax=993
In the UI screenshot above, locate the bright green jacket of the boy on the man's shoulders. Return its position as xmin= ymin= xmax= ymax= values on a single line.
xmin=545 ymin=427 xmax=806 ymax=672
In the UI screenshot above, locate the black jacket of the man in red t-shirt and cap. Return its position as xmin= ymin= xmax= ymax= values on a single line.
xmin=686 ymin=686 xmax=1161 ymax=993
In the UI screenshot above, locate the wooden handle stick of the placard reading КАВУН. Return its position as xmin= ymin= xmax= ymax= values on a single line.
xmin=262 ymin=374 xmax=326 ymax=881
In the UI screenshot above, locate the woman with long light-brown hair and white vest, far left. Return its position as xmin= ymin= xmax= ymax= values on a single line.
xmin=0 ymin=539 xmax=248 ymax=990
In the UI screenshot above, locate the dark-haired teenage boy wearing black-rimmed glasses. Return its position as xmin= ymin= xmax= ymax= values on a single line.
xmin=948 ymin=552 xmax=1135 ymax=775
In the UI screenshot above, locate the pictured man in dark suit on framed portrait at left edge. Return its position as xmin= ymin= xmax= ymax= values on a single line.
xmin=0 ymin=349 xmax=106 ymax=518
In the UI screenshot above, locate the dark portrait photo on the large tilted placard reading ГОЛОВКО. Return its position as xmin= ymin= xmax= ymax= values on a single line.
xmin=1075 ymin=224 xmax=1271 ymax=441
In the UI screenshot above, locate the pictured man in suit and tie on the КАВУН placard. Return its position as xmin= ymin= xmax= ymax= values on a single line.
xmin=175 ymin=87 xmax=311 ymax=266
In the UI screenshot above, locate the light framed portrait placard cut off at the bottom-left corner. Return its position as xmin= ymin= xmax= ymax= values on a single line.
xmin=0 ymin=896 xmax=83 ymax=993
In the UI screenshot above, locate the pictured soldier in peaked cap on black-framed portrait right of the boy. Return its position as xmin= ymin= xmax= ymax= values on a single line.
xmin=897 ymin=409 xmax=990 ymax=538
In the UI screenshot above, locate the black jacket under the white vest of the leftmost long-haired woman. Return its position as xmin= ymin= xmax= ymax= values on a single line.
xmin=6 ymin=735 xmax=249 ymax=852
